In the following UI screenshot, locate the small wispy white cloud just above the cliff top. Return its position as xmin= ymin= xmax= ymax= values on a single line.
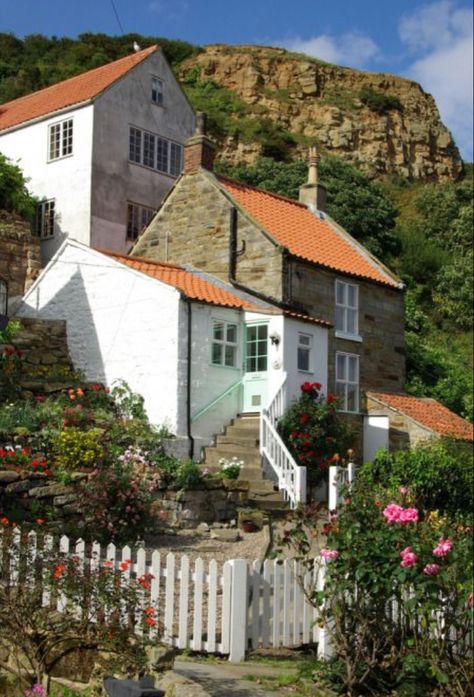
xmin=278 ymin=32 xmax=379 ymax=68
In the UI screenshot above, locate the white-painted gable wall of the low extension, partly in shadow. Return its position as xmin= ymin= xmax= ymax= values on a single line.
xmin=18 ymin=243 xmax=181 ymax=435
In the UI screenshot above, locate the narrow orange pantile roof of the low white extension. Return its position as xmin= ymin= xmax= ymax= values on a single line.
xmin=97 ymin=249 xmax=258 ymax=310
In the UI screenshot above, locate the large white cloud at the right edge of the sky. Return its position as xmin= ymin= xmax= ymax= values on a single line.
xmin=399 ymin=0 xmax=473 ymax=160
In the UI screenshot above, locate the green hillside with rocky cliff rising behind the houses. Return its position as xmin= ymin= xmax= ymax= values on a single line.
xmin=0 ymin=34 xmax=473 ymax=420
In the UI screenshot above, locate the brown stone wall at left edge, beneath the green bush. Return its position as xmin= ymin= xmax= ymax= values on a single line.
xmin=0 ymin=211 xmax=41 ymax=313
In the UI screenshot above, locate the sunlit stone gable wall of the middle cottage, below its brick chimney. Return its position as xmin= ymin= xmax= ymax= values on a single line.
xmin=132 ymin=170 xmax=282 ymax=297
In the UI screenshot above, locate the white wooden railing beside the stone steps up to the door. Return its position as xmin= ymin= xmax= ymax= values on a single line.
xmin=260 ymin=373 xmax=306 ymax=508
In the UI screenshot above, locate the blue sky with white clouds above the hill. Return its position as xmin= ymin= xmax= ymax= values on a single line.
xmin=0 ymin=0 xmax=473 ymax=161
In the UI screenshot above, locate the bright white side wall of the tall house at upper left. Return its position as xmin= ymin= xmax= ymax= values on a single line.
xmin=0 ymin=105 xmax=93 ymax=260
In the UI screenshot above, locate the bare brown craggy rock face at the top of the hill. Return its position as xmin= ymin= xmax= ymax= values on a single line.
xmin=180 ymin=45 xmax=462 ymax=181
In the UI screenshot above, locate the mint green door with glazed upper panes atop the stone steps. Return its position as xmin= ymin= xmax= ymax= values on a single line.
xmin=242 ymin=322 xmax=268 ymax=412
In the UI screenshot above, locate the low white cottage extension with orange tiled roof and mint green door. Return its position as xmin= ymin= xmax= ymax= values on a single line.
xmin=18 ymin=240 xmax=329 ymax=457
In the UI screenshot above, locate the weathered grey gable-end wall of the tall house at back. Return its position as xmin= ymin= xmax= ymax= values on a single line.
xmin=92 ymin=51 xmax=194 ymax=252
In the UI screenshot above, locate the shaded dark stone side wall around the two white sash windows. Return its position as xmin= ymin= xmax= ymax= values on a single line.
xmin=291 ymin=261 xmax=405 ymax=396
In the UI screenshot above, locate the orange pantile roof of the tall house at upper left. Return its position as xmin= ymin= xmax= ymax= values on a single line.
xmin=0 ymin=46 xmax=157 ymax=131
